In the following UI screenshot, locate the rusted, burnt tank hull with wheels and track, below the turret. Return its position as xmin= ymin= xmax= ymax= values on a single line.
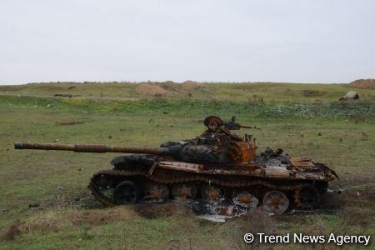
xmin=89 ymin=155 xmax=335 ymax=213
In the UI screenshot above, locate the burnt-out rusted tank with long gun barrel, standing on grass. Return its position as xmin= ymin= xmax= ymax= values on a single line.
xmin=15 ymin=116 xmax=338 ymax=214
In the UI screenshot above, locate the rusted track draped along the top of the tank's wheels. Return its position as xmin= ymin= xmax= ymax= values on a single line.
xmin=88 ymin=170 xmax=308 ymax=209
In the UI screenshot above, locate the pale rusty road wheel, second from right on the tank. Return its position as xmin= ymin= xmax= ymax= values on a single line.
xmin=263 ymin=190 xmax=289 ymax=214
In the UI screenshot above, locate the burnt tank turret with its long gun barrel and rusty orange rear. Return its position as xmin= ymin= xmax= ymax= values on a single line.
xmin=14 ymin=116 xmax=257 ymax=164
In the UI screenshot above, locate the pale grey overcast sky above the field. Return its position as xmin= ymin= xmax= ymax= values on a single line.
xmin=0 ymin=0 xmax=375 ymax=84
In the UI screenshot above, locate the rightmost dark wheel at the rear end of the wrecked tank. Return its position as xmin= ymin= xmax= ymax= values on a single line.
xmin=294 ymin=184 xmax=320 ymax=209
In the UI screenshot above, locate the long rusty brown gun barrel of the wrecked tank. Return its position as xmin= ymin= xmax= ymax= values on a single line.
xmin=14 ymin=142 xmax=174 ymax=155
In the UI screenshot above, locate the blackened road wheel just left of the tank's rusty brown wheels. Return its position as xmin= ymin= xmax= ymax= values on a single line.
xmin=113 ymin=181 xmax=141 ymax=205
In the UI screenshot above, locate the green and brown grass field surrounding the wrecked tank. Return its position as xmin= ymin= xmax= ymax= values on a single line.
xmin=0 ymin=83 xmax=375 ymax=249
